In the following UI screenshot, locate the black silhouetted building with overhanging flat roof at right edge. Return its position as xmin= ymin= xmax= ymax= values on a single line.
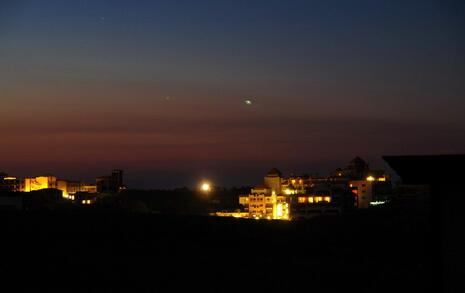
xmin=383 ymin=155 xmax=465 ymax=292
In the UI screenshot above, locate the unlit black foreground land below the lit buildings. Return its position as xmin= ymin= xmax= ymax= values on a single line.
xmin=0 ymin=198 xmax=439 ymax=292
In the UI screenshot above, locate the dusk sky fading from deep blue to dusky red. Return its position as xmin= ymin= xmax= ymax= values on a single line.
xmin=0 ymin=0 xmax=465 ymax=188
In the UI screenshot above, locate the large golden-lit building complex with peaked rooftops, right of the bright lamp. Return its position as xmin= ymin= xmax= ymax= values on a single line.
xmin=239 ymin=157 xmax=392 ymax=219
